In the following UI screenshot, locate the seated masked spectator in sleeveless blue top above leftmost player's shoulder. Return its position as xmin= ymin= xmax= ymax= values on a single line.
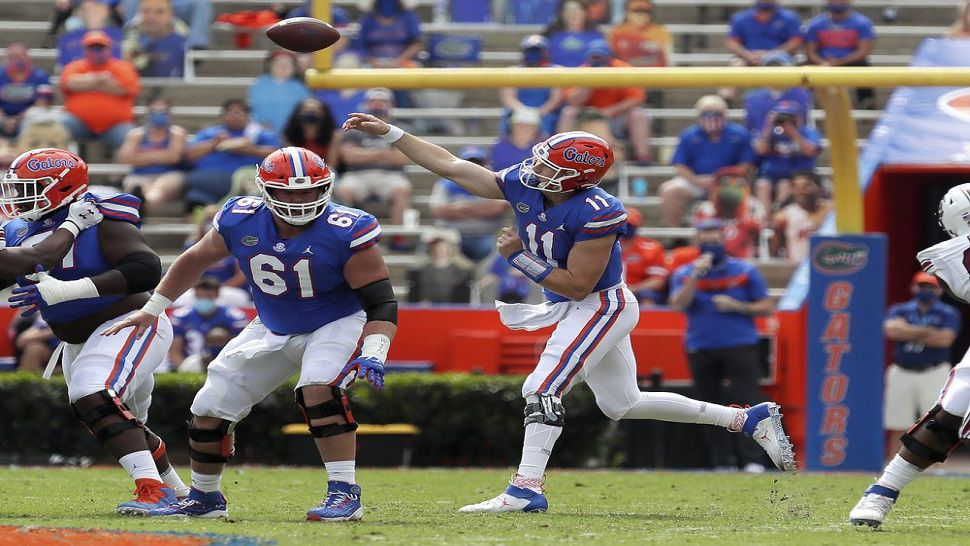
xmin=117 ymin=98 xmax=187 ymax=214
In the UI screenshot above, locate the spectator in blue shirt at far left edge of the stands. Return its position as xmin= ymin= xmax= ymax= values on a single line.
xmin=0 ymin=42 xmax=50 ymax=138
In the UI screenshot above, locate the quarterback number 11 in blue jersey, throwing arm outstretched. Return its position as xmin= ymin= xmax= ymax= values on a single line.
xmin=344 ymin=110 xmax=795 ymax=512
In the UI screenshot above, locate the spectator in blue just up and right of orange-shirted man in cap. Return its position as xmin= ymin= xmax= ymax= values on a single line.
xmin=121 ymin=0 xmax=188 ymax=78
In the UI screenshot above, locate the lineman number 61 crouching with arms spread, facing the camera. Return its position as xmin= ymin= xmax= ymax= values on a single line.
xmin=105 ymin=147 xmax=397 ymax=521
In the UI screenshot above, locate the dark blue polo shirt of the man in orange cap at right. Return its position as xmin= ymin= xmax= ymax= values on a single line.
xmin=886 ymin=299 xmax=960 ymax=370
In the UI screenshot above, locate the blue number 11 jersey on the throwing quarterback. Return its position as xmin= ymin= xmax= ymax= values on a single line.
xmin=498 ymin=165 xmax=626 ymax=301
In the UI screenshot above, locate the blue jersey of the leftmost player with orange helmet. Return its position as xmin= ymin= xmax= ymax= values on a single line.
xmin=3 ymin=193 xmax=141 ymax=323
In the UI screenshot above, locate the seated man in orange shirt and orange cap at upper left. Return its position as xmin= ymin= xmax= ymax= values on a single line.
xmin=61 ymin=30 xmax=141 ymax=152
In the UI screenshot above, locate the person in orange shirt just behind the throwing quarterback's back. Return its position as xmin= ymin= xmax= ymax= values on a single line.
xmin=620 ymin=208 xmax=670 ymax=306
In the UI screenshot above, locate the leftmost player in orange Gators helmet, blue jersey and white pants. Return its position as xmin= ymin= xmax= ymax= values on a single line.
xmin=0 ymin=148 xmax=188 ymax=515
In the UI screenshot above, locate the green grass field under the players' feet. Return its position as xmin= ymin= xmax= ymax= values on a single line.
xmin=0 ymin=468 xmax=970 ymax=545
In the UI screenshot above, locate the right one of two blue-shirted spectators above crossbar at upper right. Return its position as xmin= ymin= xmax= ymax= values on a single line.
xmin=804 ymin=0 xmax=876 ymax=108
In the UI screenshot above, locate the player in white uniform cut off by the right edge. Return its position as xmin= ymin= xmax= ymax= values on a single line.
xmin=849 ymin=184 xmax=970 ymax=527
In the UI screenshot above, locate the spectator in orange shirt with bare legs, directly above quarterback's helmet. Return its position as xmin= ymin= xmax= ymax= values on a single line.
xmin=559 ymin=40 xmax=650 ymax=165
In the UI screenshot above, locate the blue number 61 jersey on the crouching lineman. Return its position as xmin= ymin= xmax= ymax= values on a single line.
xmin=212 ymin=197 xmax=381 ymax=334
